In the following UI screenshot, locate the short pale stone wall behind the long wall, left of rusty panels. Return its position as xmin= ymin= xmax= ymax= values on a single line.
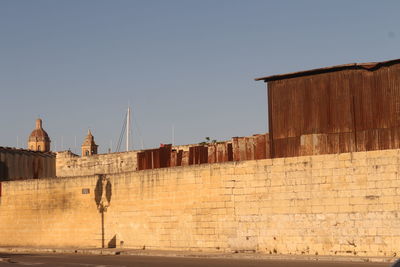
xmin=56 ymin=151 xmax=137 ymax=177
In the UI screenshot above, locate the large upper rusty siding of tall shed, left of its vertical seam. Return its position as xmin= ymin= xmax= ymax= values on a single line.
xmin=268 ymin=73 xmax=353 ymax=140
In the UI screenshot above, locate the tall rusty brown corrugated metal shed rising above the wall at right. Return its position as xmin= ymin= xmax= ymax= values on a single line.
xmin=256 ymin=59 xmax=400 ymax=158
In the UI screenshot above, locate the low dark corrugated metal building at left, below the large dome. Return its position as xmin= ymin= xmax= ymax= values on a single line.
xmin=0 ymin=147 xmax=56 ymax=181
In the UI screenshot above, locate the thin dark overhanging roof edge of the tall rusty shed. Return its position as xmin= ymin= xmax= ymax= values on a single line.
xmin=254 ymin=59 xmax=400 ymax=82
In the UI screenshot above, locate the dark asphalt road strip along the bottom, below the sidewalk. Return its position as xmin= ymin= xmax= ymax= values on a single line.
xmin=0 ymin=254 xmax=390 ymax=267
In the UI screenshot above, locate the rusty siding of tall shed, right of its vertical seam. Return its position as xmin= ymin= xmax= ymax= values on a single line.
xmin=352 ymin=65 xmax=400 ymax=151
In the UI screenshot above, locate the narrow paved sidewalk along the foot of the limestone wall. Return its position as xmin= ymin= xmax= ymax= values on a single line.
xmin=0 ymin=247 xmax=397 ymax=262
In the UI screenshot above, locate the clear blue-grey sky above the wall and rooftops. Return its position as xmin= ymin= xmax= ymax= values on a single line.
xmin=0 ymin=0 xmax=400 ymax=152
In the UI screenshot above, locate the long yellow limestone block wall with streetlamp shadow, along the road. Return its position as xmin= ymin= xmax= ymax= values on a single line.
xmin=0 ymin=150 xmax=400 ymax=256
